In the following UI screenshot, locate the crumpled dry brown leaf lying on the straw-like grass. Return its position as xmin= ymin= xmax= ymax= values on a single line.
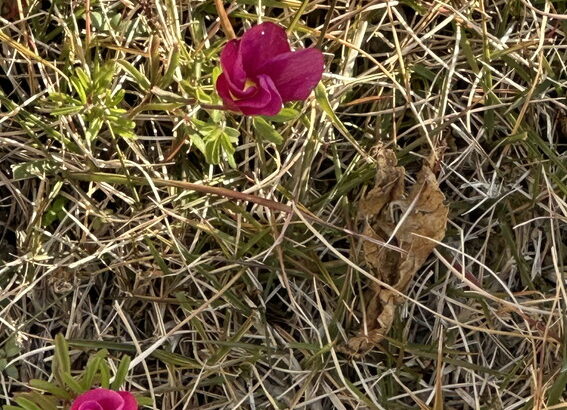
xmin=344 ymin=148 xmax=448 ymax=354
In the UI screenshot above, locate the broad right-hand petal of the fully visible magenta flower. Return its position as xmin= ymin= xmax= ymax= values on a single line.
xmin=260 ymin=48 xmax=325 ymax=102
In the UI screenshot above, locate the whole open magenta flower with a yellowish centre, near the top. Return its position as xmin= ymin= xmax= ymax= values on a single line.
xmin=216 ymin=23 xmax=324 ymax=115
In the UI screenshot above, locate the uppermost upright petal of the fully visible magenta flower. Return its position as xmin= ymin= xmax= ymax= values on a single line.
xmin=240 ymin=22 xmax=291 ymax=78
